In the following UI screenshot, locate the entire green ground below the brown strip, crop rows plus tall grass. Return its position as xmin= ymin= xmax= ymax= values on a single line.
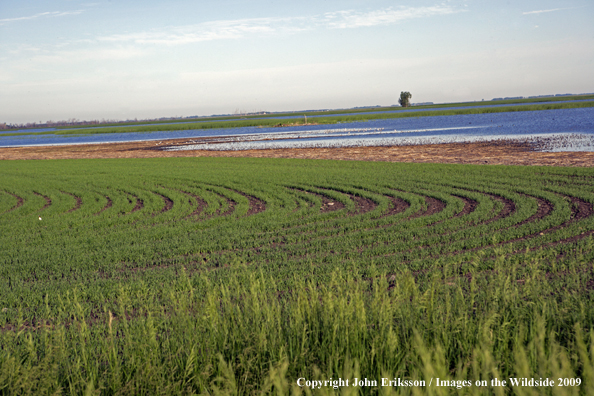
xmin=0 ymin=158 xmax=594 ymax=395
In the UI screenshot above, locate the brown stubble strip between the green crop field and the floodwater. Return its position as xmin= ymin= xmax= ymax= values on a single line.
xmin=0 ymin=139 xmax=594 ymax=167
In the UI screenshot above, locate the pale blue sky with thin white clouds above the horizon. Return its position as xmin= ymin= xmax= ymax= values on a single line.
xmin=0 ymin=0 xmax=594 ymax=123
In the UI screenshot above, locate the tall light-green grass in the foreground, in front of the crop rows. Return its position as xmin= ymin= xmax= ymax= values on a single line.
xmin=0 ymin=254 xmax=594 ymax=395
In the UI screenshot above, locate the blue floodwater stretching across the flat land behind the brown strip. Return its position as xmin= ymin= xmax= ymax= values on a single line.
xmin=0 ymin=107 xmax=594 ymax=151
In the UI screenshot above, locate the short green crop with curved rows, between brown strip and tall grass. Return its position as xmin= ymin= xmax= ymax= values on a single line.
xmin=0 ymin=159 xmax=594 ymax=322
